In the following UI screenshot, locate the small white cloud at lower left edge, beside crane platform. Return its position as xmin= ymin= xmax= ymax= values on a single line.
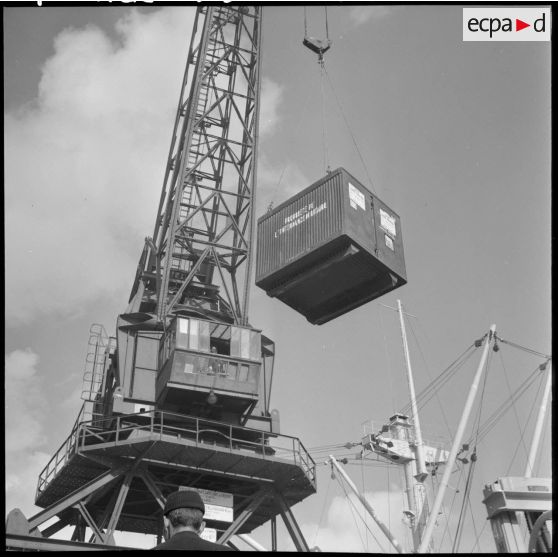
xmin=5 ymin=349 xmax=50 ymax=515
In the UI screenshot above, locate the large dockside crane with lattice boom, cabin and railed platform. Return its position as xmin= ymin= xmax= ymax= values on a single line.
xmin=7 ymin=5 xmax=316 ymax=551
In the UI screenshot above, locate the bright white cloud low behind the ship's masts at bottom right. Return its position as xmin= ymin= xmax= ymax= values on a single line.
xmin=302 ymin=487 xmax=408 ymax=553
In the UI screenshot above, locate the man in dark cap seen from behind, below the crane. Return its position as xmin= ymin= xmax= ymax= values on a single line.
xmin=153 ymin=490 xmax=232 ymax=552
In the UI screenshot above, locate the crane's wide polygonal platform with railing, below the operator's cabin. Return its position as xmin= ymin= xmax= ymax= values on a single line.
xmin=35 ymin=411 xmax=316 ymax=535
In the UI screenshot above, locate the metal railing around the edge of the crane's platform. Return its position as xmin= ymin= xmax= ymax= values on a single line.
xmin=37 ymin=410 xmax=316 ymax=497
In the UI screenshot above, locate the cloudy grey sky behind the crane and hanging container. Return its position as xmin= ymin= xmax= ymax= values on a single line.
xmin=3 ymin=5 xmax=551 ymax=552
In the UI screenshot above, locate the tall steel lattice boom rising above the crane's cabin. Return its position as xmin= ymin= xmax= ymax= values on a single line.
xmin=130 ymin=6 xmax=261 ymax=325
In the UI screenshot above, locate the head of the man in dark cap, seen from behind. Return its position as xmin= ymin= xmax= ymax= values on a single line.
xmin=163 ymin=490 xmax=205 ymax=540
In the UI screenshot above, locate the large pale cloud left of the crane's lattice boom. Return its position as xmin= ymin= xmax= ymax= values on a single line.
xmin=4 ymin=8 xmax=194 ymax=324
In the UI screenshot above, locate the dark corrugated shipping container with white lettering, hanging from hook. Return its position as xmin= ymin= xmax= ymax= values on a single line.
xmin=256 ymin=168 xmax=407 ymax=324
